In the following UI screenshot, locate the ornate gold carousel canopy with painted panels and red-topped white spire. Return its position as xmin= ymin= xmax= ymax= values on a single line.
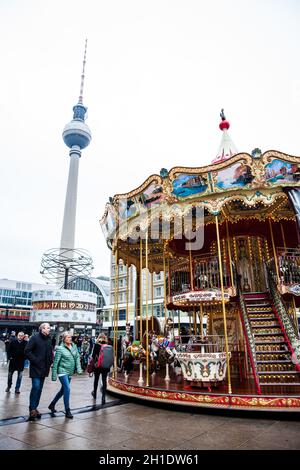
xmin=100 ymin=113 xmax=300 ymax=268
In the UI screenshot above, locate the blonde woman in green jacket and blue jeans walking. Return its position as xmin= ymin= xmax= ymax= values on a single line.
xmin=48 ymin=331 xmax=82 ymax=418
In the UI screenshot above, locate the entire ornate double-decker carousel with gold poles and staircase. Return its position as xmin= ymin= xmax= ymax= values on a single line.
xmin=100 ymin=110 xmax=300 ymax=412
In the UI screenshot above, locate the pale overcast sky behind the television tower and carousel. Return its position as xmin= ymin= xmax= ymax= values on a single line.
xmin=0 ymin=0 xmax=300 ymax=282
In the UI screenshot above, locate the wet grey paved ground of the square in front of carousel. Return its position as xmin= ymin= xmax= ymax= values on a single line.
xmin=0 ymin=365 xmax=300 ymax=450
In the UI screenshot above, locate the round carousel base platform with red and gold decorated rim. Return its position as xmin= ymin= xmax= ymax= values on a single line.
xmin=108 ymin=370 xmax=300 ymax=413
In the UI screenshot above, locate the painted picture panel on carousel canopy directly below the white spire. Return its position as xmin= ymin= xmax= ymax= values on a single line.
xmin=214 ymin=162 xmax=254 ymax=190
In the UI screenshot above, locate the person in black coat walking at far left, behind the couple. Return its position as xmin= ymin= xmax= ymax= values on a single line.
xmin=5 ymin=331 xmax=27 ymax=394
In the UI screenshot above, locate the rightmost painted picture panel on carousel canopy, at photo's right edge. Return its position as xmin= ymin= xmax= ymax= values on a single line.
xmin=265 ymin=159 xmax=300 ymax=184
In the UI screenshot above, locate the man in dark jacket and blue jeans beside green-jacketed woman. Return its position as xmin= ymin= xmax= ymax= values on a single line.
xmin=25 ymin=323 xmax=53 ymax=421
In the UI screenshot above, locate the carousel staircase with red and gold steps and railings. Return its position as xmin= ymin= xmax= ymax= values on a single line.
xmin=244 ymin=293 xmax=300 ymax=392
